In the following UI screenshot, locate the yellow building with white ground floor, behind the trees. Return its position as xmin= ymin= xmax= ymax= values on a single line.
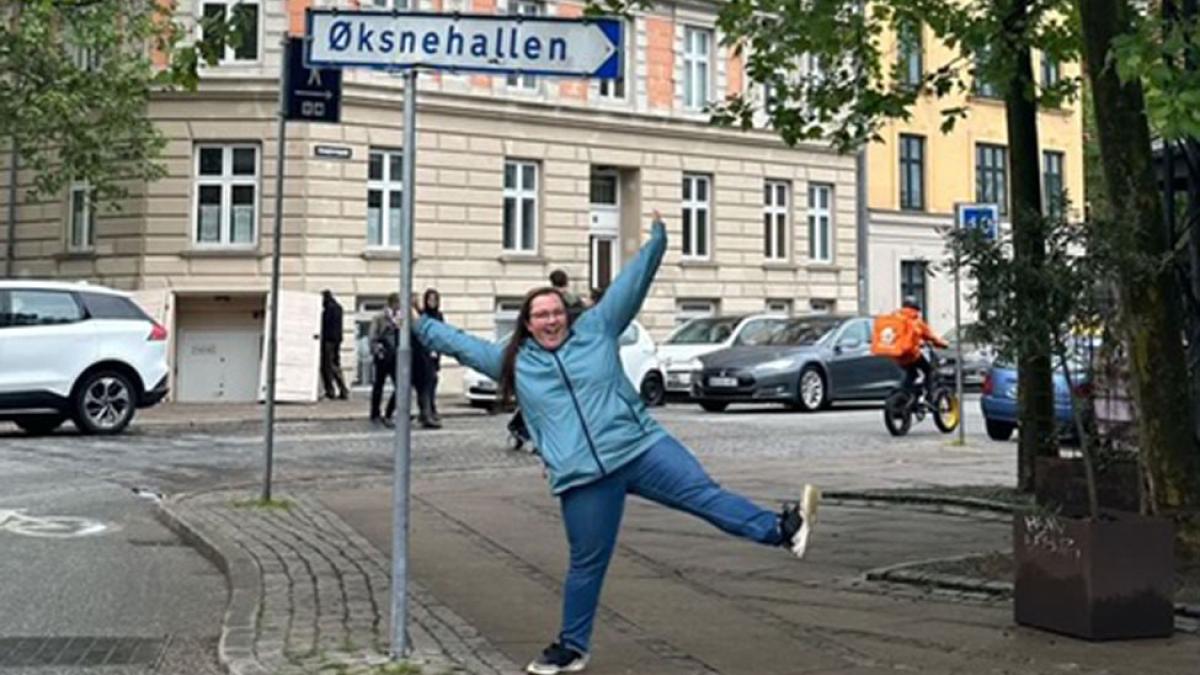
xmin=866 ymin=22 xmax=1084 ymax=330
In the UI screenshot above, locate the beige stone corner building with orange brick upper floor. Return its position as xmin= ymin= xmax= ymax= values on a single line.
xmin=0 ymin=0 xmax=858 ymax=401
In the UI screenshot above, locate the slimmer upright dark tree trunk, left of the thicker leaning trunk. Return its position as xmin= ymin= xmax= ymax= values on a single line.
xmin=996 ymin=0 xmax=1057 ymax=492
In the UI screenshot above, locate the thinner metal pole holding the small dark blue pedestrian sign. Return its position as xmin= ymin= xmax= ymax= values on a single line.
xmin=263 ymin=35 xmax=288 ymax=502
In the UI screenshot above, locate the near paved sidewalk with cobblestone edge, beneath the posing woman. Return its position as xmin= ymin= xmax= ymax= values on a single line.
xmin=166 ymin=468 xmax=1200 ymax=675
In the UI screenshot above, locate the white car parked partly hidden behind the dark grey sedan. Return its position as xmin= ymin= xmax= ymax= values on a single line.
xmin=659 ymin=313 xmax=787 ymax=398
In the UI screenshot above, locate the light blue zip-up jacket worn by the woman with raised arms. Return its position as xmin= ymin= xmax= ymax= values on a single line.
xmin=416 ymin=221 xmax=667 ymax=487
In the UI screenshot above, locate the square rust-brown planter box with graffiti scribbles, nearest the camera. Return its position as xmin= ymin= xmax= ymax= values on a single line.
xmin=1013 ymin=512 xmax=1175 ymax=640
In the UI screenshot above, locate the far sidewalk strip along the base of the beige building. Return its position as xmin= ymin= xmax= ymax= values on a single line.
xmin=134 ymin=393 xmax=487 ymax=428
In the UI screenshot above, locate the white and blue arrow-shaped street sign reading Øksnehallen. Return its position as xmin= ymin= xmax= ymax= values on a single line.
xmin=307 ymin=10 xmax=622 ymax=78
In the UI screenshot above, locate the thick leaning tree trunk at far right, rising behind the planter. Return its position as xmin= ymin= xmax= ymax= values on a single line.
xmin=1078 ymin=0 xmax=1200 ymax=513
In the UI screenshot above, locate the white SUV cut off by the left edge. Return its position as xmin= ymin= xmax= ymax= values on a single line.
xmin=0 ymin=280 xmax=168 ymax=434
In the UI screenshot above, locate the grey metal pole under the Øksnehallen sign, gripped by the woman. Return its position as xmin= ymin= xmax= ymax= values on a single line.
xmin=391 ymin=68 xmax=416 ymax=661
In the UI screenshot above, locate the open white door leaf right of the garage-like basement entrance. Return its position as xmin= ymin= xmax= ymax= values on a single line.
xmin=258 ymin=291 xmax=322 ymax=402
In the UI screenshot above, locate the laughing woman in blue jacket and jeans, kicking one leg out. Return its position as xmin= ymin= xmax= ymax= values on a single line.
xmin=416 ymin=211 xmax=820 ymax=675
